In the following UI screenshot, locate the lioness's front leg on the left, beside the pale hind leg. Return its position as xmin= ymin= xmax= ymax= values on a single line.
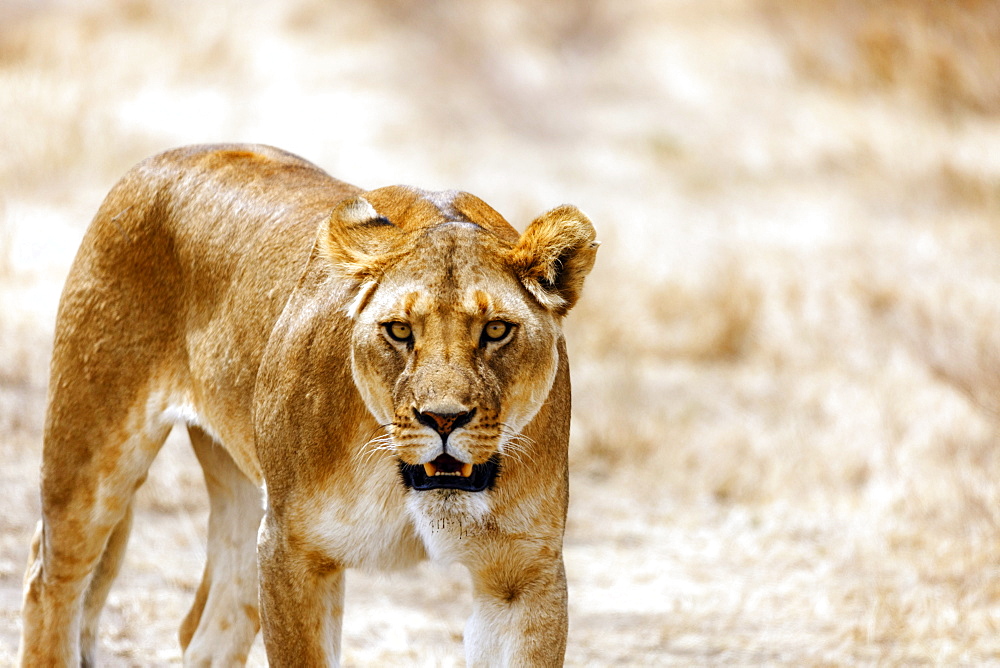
xmin=257 ymin=517 xmax=344 ymax=668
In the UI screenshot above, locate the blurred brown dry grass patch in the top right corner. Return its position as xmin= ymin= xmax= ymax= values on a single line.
xmin=764 ymin=0 xmax=1000 ymax=116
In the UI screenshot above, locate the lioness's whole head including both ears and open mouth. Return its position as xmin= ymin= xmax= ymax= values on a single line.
xmin=319 ymin=187 xmax=597 ymax=504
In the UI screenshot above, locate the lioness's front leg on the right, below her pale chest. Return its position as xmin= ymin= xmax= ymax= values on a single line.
xmin=465 ymin=555 xmax=568 ymax=666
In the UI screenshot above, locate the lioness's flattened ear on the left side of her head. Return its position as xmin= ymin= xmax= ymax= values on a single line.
xmin=318 ymin=196 xmax=399 ymax=281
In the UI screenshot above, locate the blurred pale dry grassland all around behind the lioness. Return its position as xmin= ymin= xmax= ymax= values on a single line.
xmin=0 ymin=0 xmax=1000 ymax=666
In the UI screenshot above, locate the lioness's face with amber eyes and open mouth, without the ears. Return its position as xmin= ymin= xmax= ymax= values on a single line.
xmin=353 ymin=223 xmax=559 ymax=491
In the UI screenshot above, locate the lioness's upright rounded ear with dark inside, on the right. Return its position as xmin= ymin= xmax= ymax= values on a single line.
xmin=508 ymin=204 xmax=599 ymax=315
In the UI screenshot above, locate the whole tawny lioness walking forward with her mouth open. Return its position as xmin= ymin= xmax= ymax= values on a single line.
xmin=20 ymin=145 xmax=597 ymax=666
